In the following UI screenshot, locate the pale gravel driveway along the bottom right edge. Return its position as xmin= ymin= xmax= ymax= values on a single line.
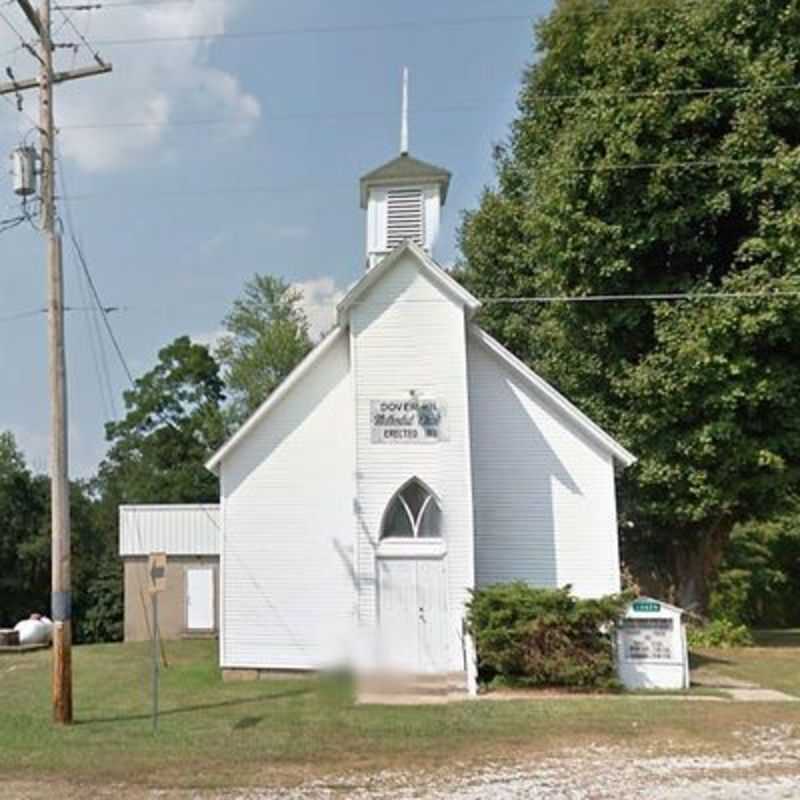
xmin=222 ymin=725 xmax=800 ymax=800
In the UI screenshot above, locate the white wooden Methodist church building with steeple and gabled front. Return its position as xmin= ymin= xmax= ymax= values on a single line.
xmin=121 ymin=98 xmax=635 ymax=683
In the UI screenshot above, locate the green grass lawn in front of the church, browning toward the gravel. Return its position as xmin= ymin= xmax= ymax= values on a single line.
xmin=0 ymin=641 xmax=800 ymax=788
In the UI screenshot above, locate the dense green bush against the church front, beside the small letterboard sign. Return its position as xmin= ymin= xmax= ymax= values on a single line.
xmin=467 ymin=582 xmax=630 ymax=690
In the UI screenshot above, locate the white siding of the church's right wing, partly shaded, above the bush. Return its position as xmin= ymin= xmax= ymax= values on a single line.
xmin=469 ymin=335 xmax=620 ymax=596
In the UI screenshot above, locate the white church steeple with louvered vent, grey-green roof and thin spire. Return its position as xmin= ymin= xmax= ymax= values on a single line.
xmin=361 ymin=68 xmax=450 ymax=269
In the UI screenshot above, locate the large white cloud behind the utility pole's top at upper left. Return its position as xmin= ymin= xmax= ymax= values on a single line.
xmin=0 ymin=0 xmax=261 ymax=172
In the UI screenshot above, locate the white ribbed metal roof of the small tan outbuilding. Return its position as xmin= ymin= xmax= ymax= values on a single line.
xmin=119 ymin=505 xmax=220 ymax=556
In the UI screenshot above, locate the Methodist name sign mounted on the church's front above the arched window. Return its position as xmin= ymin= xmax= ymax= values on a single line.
xmin=370 ymin=397 xmax=447 ymax=444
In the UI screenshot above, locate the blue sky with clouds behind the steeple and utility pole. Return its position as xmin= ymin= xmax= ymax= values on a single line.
xmin=0 ymin=0 xmax=551 ymax=476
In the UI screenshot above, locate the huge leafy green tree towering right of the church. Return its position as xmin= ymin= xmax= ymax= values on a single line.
xmin=461 ymin=0 xmax=800 ymax=608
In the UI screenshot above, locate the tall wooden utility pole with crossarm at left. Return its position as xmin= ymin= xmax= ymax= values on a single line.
xmin=0 ymin=0 xmax=111 ymax=725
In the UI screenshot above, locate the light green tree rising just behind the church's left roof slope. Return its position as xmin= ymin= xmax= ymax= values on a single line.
xmin=216 ymin=275 xmax=311 ymax=424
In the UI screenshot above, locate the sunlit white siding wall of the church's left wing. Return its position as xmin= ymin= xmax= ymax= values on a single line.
xmin=221 ymin=334 xmax=356 ymax=669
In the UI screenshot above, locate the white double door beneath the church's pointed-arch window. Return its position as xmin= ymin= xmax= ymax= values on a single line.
xmin=378 ymin=558 xmax=448 ymax=674
